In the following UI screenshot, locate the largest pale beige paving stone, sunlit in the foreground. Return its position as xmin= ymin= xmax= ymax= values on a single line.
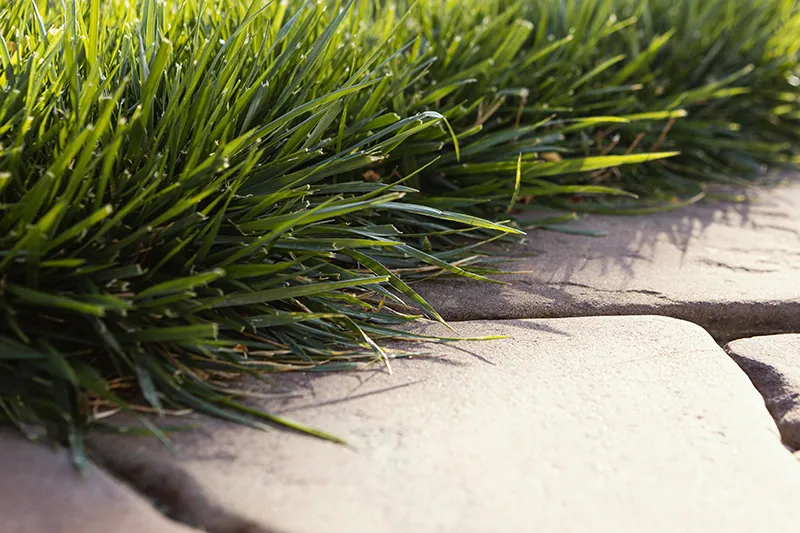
xmin=87 ymin=316 xmax=800 ymax=533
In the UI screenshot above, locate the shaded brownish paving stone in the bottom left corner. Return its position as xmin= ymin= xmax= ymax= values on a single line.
xmin=0 ymin=430 xmax=199 ymax=533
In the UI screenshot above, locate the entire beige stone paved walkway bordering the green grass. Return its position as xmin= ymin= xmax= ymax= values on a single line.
xmin=0 ymin=180 xmax=800 ymax=533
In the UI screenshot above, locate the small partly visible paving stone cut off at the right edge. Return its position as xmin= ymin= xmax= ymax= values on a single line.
xmin=725 ymin=334 xmax=800 ymax=449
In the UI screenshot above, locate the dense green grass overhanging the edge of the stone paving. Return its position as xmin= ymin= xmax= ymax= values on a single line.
xmin=0 ymin=0 xmax=800 ymax=456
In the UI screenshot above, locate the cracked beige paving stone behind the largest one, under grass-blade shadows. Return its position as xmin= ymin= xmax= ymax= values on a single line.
xmin=415 ymin=181 xmax=800 ymax=341
